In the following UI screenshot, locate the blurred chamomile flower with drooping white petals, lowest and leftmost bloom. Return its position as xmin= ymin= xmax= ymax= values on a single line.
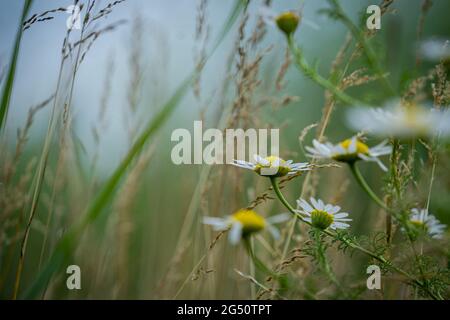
xmin=203 ymin=209 xmax=290 ymax=244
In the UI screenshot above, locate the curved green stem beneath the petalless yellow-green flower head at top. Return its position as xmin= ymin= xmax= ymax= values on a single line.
xmin=287 ymin=34 xmax=362 ymax=105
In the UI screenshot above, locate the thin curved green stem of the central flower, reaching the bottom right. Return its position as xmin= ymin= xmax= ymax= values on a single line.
xmin=270 ymin=176 xmax=442 ymax=300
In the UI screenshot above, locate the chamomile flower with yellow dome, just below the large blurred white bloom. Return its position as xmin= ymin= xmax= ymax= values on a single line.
xmin=306 ymin=136 xmax=392 ymax=171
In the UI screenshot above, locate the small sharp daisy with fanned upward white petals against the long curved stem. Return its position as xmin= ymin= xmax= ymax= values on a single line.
xmin=297 ymin=197 xmax=352 ymax=230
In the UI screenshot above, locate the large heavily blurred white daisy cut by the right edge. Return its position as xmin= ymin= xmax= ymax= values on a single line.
xmin=347 ymin=103 xmax=450 ymax=138
